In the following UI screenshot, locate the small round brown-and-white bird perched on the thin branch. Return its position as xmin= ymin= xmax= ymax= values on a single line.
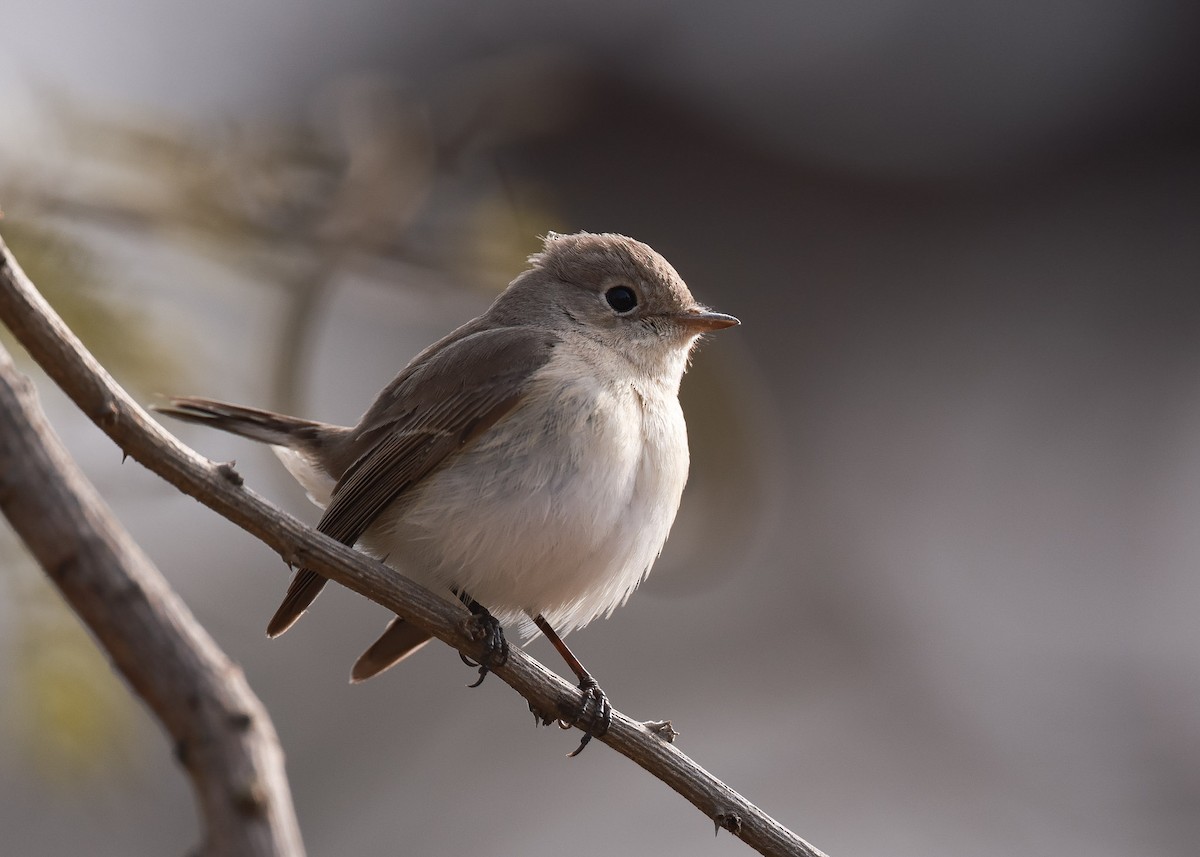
xmin=156 ymin=232 xmax=739 ymax=755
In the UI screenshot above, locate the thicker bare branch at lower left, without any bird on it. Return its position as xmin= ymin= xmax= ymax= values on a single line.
xmin=0 ymin=348 xmax=304 ymax=857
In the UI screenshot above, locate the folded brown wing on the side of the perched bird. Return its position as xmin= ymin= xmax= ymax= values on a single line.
xmin=266 ymin=328 xmax=558 ymax=636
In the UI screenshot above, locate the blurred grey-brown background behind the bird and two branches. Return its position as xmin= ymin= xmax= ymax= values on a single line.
xmin=0 ymin=0 xmax=1200 ymax=857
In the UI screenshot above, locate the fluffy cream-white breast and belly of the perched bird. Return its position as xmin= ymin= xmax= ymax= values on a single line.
xmin=364 ymin=374 xmax=688 ymax=633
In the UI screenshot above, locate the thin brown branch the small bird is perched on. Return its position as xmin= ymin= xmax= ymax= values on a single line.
xmin=0 ymin=230 xmax=824 ymax=857
